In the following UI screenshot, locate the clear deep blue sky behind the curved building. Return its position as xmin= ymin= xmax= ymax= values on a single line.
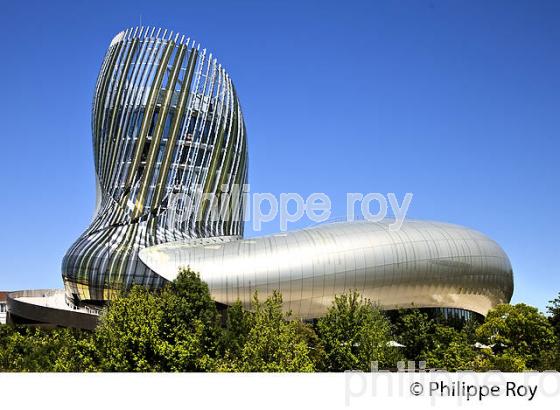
xmin=0 ymin=0 xmax=560 ymax=309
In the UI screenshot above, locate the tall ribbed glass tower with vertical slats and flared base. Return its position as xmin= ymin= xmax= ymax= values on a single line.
xmin=62 ymin=28 xmax=247 ymax=303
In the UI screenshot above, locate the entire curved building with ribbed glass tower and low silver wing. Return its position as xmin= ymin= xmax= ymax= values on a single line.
xmin=8 ymin=28 xmax=513 ymax=328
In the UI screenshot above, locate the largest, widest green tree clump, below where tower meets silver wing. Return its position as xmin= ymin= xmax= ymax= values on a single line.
xmin=91 ymin=270 xmax=220 ymax=372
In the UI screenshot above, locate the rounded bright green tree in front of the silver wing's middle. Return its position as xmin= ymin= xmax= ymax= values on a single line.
xmin=317 ymin=291 xmax=398 ymax=372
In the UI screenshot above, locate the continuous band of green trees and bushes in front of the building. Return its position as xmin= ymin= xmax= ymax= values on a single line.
xmin=0 ymin=278 xmax=560 ymax=372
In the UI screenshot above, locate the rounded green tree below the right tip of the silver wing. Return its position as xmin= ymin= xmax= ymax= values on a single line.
xmin=476 ymin=303 xmax=558 ymax=371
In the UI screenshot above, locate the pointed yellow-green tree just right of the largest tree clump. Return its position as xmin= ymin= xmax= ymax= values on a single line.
xmin=220 ymin=292 xmax=314 ymax=372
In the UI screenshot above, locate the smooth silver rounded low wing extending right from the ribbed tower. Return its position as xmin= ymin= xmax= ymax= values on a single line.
xmin=140 ymin=221 xmax=513 ymax=318
